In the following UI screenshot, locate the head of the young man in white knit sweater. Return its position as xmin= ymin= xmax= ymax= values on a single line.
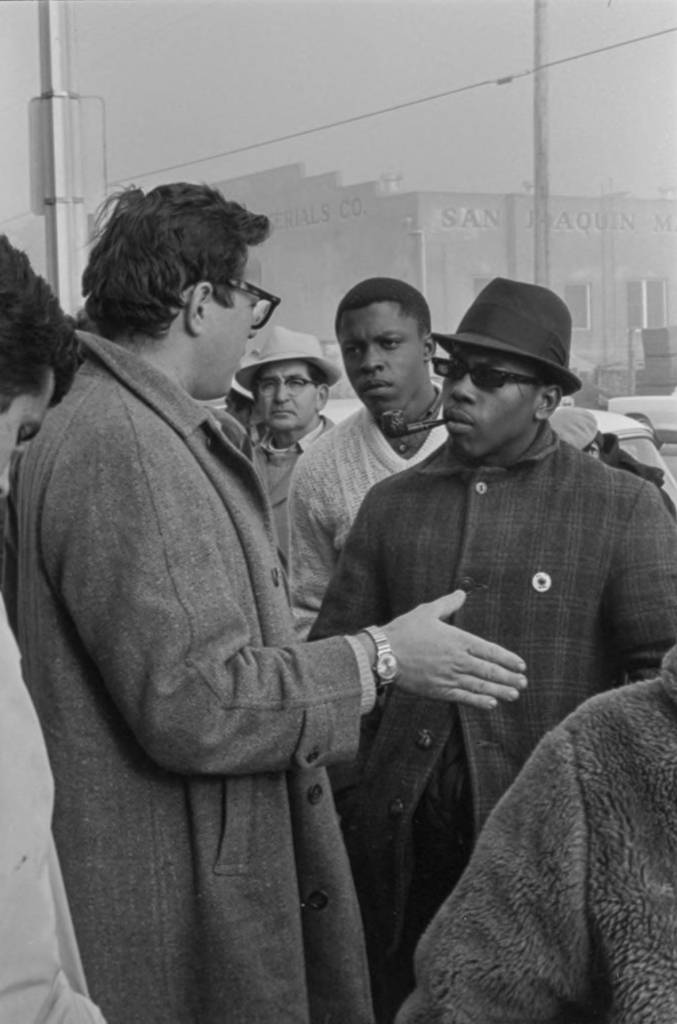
xmin=334 ymin=278 xmax=435 ymax=421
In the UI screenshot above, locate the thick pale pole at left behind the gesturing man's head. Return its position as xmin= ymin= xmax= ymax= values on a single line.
xmin=31 ymin=0 xmax=87 ymax=312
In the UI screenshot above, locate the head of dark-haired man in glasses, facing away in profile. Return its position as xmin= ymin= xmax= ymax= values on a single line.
xmin=82 ymin=182 xmax=272 ymax=399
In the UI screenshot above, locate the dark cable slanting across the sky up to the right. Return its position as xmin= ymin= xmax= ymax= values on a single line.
xmin=112 ymin=27 xmax=677 ymax=184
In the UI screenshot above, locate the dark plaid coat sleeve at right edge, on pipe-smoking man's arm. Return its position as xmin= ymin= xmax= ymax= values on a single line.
xmin=603 ymin=482 xmax=677 ymax=680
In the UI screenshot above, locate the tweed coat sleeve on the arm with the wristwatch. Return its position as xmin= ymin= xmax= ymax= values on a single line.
xmin=33 ymin=407 xmax=362 ymax=774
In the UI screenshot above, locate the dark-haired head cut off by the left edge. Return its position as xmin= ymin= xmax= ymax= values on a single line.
xmin=0 ymin=234 xmax=78 ymax=495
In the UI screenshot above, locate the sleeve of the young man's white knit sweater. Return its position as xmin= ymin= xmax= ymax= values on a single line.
xmin=288 ymin=449 xmax=338 ymax=640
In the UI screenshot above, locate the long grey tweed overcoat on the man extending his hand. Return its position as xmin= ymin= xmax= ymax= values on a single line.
xmin=2 ymin=337 xmax=372 ymax=1024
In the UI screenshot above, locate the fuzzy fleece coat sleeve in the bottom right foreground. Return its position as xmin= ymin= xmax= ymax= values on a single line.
xmin=396 ymin=728 xmax=596 ymax=1024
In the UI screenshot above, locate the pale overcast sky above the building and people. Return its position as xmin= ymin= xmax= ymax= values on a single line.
xmin=0 ymin=0 xmax=677 ymax=266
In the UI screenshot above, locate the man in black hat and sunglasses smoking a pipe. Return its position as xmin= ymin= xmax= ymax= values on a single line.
xmin=311 ymin=279 xmax=677 ymax=1021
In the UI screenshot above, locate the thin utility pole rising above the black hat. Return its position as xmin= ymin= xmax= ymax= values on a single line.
xmin=534 ymin=0 xmax=550 ymax=287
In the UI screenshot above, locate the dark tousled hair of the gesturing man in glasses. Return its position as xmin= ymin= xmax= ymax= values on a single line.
xmin=82 ymin=182 xmax=270 ymax=339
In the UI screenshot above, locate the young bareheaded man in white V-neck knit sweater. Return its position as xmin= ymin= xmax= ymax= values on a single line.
xmin=289 ymin=278 xmax=446 ymax=638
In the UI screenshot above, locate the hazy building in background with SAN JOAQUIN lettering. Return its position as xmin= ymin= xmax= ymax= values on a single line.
xmin=217 ymin=165 xmax=677 ymax=393
